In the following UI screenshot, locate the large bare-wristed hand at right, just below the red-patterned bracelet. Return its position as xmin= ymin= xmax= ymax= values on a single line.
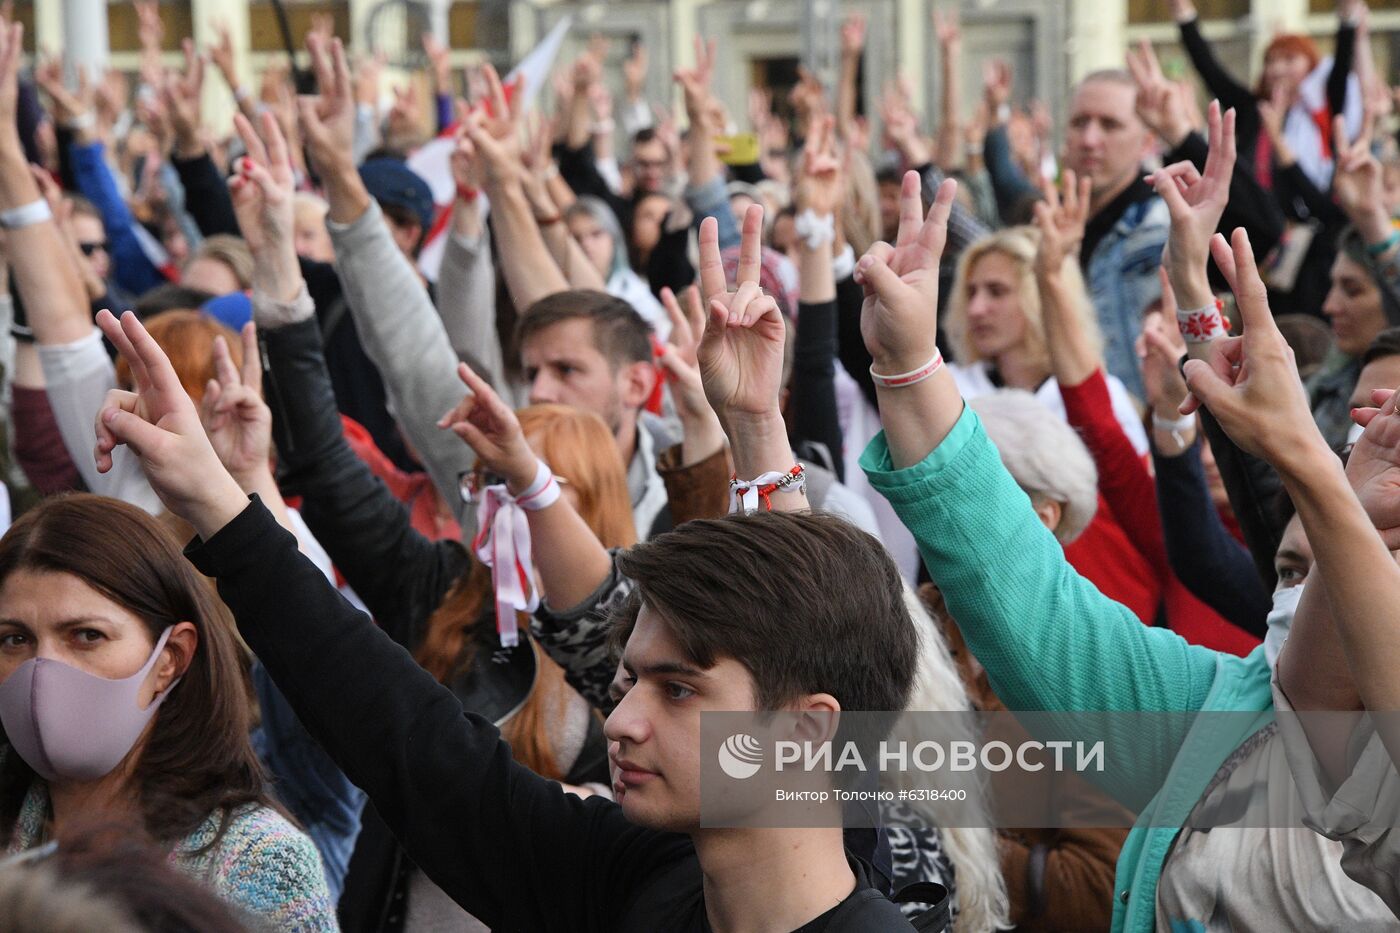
xmin=1182 ymin=228 xmax=1326 ymax=474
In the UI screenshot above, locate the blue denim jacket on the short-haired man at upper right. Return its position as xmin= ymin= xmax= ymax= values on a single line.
xmin=1085 ymin=198 xmax=1172 ymax=398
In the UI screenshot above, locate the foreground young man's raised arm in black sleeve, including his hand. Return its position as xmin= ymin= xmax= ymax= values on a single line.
xmin=88 ymin=306 xmax=692 ymax=933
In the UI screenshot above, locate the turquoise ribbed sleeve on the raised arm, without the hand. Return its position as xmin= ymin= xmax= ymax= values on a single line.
xmin=861 ymin=409 xmax=1215 ymax=806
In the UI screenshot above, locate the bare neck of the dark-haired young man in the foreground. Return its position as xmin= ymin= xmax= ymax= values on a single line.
xmin=692 ymin=827 xmax=855 ymax=933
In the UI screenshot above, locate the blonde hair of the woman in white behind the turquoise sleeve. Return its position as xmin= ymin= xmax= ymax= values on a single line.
xmin=944 ymin=227 xmax=1103 ymax=373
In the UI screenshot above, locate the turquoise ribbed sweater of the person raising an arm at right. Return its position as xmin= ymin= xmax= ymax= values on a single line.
xmin=861 ymin=409 xmax=1273 ymax=933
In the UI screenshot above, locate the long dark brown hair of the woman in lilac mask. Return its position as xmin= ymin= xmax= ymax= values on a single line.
xmin=0 ymin=495 xmax=273 ymax=849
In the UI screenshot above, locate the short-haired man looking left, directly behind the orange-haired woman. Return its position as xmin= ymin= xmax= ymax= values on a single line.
xmin=515 ymin=290 xmax=676 ymax=541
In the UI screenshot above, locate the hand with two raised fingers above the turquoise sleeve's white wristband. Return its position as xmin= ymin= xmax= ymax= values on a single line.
xmin=855 ymin=172 xmax=958 ymax=375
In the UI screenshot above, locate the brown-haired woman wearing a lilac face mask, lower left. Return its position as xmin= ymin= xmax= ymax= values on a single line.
xmin=0 ymin=495 xmax=336 ymax=930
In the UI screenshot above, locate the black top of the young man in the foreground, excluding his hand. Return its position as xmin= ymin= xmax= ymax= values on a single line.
xmin=186 ymin=499 xmax=929 ymax=933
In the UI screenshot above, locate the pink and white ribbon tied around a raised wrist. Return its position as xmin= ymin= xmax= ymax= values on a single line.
xmin=472 ymin=461 xmax=560 ymax=647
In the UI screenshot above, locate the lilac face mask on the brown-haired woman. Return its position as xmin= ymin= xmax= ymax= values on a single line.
xmin=0 ymin=629 xmax=179 ymax=782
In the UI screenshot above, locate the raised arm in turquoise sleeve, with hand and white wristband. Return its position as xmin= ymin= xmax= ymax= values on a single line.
xmin=857 ymin=174 xmax=1217 ymax=799
